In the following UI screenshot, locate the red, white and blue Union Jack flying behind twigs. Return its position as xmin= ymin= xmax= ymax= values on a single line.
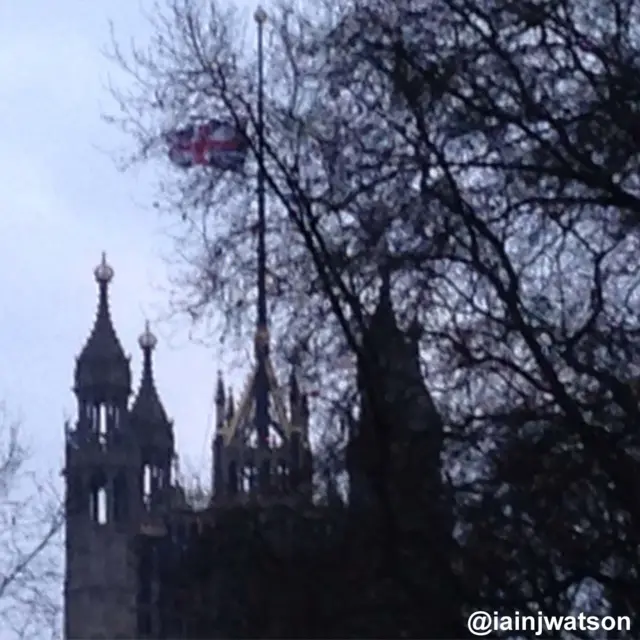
xmin=167 ymin=120 xmax=249 ymax=171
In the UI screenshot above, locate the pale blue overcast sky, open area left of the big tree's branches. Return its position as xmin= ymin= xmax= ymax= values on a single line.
xmin=0 ymin=0 xmax=254 ymax=496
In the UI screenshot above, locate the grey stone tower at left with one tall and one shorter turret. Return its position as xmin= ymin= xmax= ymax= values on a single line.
xmin=65 ymin=254 xmax=173 ymax=640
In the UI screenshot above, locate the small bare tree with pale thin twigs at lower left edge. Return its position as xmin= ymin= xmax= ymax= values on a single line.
xmin=0 ymin=406 xmax=63 ymax=640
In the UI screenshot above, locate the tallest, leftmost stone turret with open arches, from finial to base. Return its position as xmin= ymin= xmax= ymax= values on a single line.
xmin=65 ymin=254 xmax=140 ymax=640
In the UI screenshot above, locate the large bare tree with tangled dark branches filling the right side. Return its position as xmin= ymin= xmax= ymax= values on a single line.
xmin=107 ymin=0 xmax=640 ymax=635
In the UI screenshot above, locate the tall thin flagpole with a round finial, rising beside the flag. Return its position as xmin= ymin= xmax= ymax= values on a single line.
xmin=254 ymin=7 xmax=269 ymax=458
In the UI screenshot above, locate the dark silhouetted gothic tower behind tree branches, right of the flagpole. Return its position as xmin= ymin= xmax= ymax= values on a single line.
xmin=347 ymin=270 xmax=465 ymax=638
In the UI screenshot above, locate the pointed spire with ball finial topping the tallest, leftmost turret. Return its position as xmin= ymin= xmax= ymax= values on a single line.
xmin=75 ymin=252 xmax=131 ymax=394
